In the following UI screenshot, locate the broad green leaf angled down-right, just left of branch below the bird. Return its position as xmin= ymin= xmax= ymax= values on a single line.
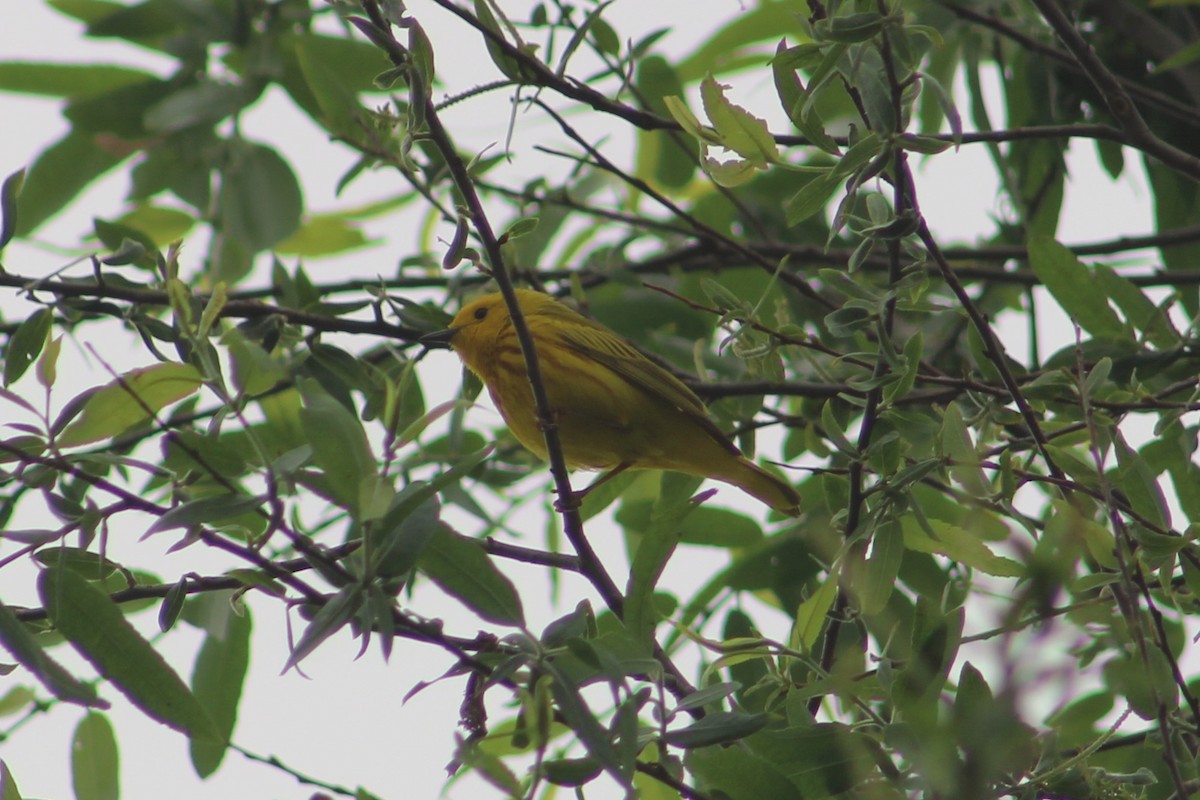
xmin=418 ymin=525 xmax=524 ymax=625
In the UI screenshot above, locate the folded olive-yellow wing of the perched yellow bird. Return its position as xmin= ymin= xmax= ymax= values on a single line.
xmin=558 ymin=315 xmax=740 ymax=455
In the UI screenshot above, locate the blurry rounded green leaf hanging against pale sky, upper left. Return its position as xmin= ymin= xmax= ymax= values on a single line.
xmin=217 ymin=142 xmax=304 ymax=253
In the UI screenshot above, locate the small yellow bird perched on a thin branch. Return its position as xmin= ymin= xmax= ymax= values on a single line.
xmin=421 ymin=289 xmax=800 ymax=516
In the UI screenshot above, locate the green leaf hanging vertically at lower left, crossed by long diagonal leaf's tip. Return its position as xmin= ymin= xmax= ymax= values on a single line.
xmin=188 ymin=593 xmax=251 ymax=778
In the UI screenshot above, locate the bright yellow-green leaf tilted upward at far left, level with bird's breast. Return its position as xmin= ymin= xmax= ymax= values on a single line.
xmin=58 ymin=363 xmax=200 ymax=447
